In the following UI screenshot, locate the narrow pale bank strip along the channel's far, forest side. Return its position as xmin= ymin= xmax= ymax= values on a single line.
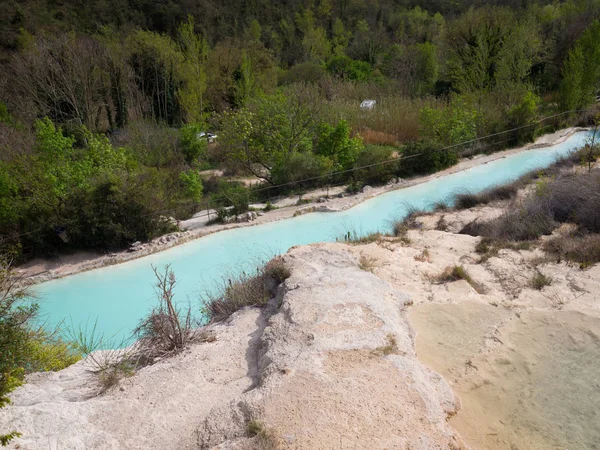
xmin=17 ymin=128 xmax=581 ymax=284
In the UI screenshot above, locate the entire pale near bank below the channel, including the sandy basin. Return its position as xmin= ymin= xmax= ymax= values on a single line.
xmin=0 ymin=171 xmax=600 ymax=450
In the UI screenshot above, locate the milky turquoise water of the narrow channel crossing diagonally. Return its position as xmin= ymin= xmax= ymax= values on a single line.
xmin=35 ymin=133 xmax=586 ymax=339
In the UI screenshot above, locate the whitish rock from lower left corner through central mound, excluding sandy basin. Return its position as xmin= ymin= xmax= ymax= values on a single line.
xmin=0 ymin=245 xmax=461 ymax=449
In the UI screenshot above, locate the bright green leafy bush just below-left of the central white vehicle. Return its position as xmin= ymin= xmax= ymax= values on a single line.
xmin=315 ymin=120 xmax=363 ymax=169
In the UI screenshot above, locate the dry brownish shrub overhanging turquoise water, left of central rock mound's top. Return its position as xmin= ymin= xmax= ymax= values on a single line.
xmin=202 ymin=257 xmax=291 ymax=322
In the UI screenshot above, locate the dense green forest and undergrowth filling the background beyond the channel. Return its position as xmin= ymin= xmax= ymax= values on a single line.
xmin=0 ymin=0 xmax=600 ymax=260
